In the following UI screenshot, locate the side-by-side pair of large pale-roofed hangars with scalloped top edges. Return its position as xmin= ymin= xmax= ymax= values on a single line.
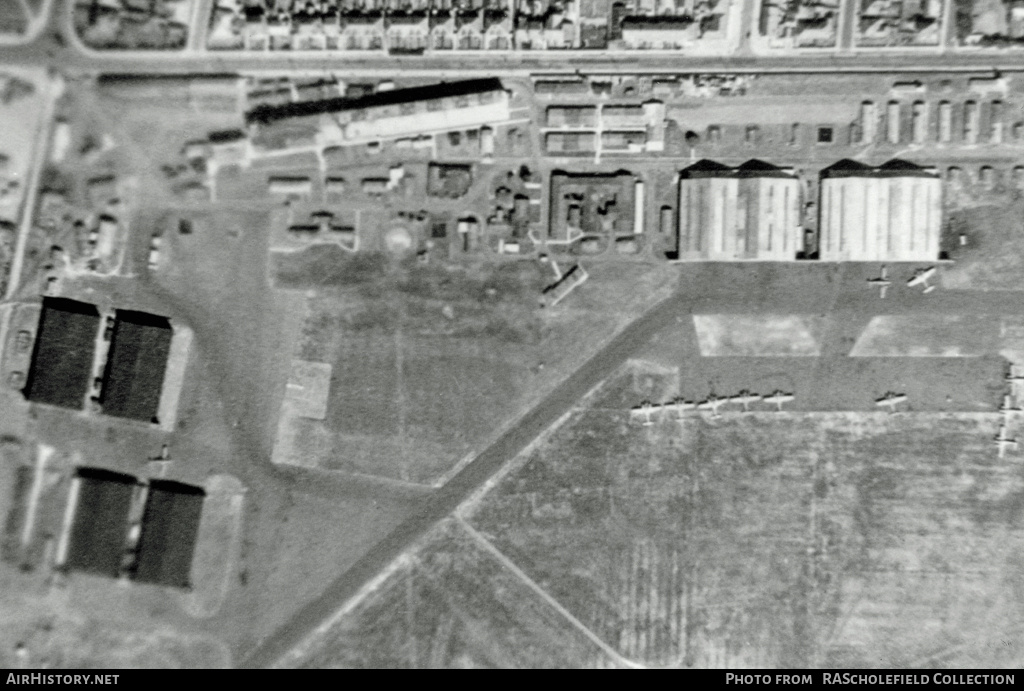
xmin=670 ymin=161 xmax=942 ymax=261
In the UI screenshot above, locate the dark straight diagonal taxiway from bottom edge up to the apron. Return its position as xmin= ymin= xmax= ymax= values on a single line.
xmin=236 ymin=288 xmax=685 ymax=667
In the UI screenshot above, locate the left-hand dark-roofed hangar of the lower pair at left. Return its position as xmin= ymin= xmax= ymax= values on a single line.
xmin=65 ymin=468 xmax=138 ymax=578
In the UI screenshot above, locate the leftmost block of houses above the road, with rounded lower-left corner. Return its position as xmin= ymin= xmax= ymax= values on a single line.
xmin=75 ymin=0 xmax=197 ymax=50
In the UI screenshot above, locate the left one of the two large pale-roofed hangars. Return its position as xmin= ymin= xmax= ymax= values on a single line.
xmin=674 ymin=161 xmax=804 ymax=261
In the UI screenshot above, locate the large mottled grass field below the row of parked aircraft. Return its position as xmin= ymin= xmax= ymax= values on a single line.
xmin=462 ymin=368 xmax=1024 ymax=667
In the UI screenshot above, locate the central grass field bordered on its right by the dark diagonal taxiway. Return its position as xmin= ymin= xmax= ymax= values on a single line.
xmin=274 ymin=248 xmax=672 ymax=483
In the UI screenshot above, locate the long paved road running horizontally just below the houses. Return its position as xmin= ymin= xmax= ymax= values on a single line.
xmin=6 ymin=0 xmax=1024 ymax=78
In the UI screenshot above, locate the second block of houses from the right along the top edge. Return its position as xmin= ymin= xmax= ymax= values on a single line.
xmin=857 ymin=0 xmax=951 ymax=47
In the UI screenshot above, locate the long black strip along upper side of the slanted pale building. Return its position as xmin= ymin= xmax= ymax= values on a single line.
xmin=246 ymin=78 xmax=503 ymax=124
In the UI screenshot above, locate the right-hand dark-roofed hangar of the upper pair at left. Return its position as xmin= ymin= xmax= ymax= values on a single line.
xmin=100 ymin=309 xmax=173 ymax=422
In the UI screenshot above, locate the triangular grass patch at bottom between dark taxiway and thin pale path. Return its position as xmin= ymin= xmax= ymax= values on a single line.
xmin=286 ymin=521 xmax=608 ymax=670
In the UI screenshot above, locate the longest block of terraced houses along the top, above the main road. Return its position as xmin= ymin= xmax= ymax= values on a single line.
xmin=209 ymin=0 xmax=732 ymax=53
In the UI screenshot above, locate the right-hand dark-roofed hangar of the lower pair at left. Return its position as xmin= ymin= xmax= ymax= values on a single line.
xmin=135 ymin=480 xmax=206 ymax=588
